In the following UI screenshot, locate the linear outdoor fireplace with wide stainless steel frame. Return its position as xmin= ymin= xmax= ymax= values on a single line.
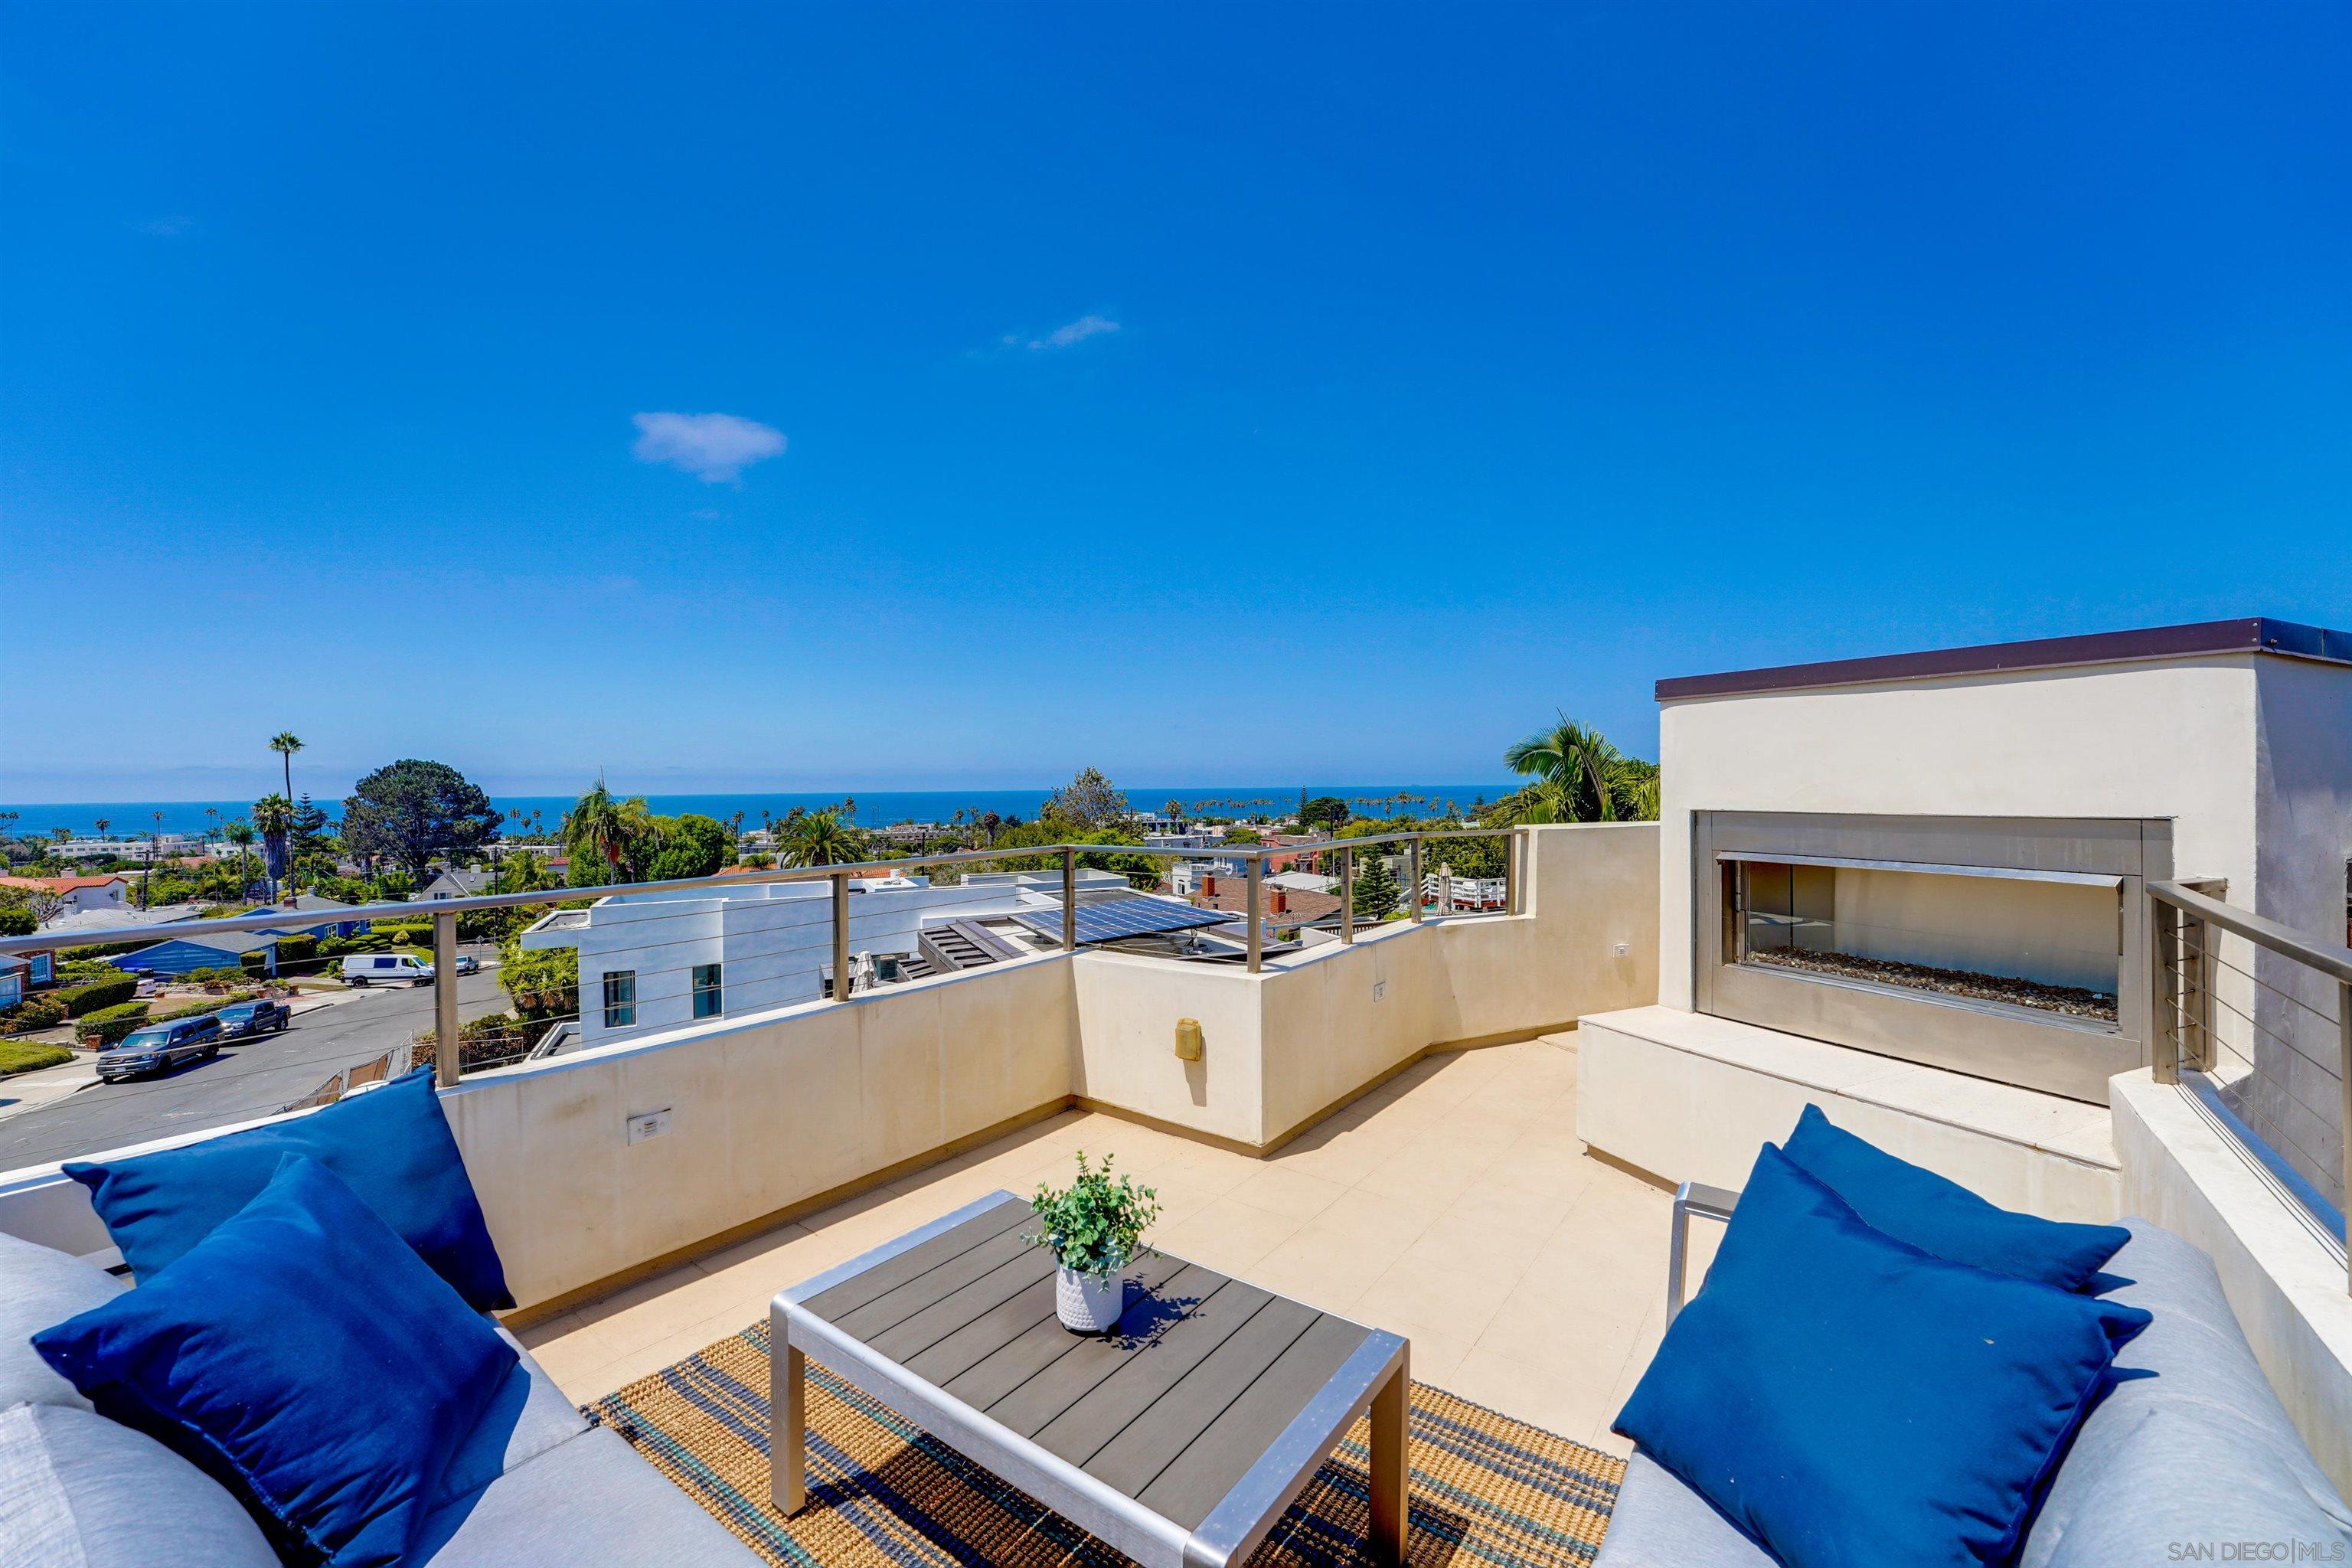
xmin=1691 ymin=811 xmax=2174 ymax=1102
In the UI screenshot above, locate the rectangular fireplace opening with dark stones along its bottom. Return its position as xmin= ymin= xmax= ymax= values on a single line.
xmin=1722 ymin=856 xmax=2122 ymax=1030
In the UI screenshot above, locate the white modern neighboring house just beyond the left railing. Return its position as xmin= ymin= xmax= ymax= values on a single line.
xmin=522 ymin=870 xmax=1134 ymax=1048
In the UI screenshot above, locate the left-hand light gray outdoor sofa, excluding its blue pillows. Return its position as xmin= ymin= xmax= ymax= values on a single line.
xmin=0 ymin=1234 xmax=760 ymax=1568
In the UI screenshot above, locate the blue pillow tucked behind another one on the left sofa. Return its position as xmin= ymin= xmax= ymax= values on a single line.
xmin=66 ymin=1067 xmax=515 ymax=1312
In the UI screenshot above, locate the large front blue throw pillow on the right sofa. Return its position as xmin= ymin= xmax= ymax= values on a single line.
xmin=1615 ymin=1145 xmax=2150 ymax=1568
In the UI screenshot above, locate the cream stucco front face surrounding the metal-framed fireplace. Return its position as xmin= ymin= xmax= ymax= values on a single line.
xmin=1658 ymin=654 xmax=2258 ymax=1008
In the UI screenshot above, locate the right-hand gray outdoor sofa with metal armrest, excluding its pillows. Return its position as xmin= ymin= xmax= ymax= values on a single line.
xmin=1595 ymin=1185 xmax=2352 ymax=1568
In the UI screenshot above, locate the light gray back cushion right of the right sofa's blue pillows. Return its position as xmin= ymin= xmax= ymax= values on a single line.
xmin=2018 ymin=1220 xmax=2352 ymax=1568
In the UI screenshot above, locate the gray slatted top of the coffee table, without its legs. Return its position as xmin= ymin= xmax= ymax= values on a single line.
xmin=779 ymin=1192 xmax=1404 ymax=1561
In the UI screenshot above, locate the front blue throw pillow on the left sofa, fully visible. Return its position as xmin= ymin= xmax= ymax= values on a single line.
xmin=33 ymin=1155 xmax=515 ymax=1568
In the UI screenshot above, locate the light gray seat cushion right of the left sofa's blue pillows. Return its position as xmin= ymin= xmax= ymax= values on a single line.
xmin=414 ymin=1427 xmax=760 ymax=1568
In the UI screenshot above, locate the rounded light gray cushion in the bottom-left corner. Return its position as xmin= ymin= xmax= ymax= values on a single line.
xmin=0 ymin=1403 xmax=277 ymax=1568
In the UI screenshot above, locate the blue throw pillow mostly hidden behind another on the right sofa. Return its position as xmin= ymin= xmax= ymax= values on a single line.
xmin=1783 ymin=1105 xmax=2131 ymax=1291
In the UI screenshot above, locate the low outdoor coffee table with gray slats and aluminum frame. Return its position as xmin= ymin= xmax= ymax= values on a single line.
xmin=769 ymin=1192 xmax=1409 ymax=1568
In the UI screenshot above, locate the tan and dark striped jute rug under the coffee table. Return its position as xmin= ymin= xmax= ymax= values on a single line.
xmin=583 ymin=1324 xmax=1625 ymax=1568
